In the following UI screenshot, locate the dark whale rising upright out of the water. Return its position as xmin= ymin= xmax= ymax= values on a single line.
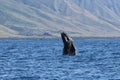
xmin=61 ymin=32 xmax=76 ymax=56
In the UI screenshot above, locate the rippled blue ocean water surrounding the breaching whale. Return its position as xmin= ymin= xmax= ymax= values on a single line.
xmin=0 ymin=39 xmax=120 ymax=80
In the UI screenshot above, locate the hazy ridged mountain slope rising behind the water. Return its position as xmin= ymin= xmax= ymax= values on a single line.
xmin=0 ymin=0 xmax=120 ymax=38
